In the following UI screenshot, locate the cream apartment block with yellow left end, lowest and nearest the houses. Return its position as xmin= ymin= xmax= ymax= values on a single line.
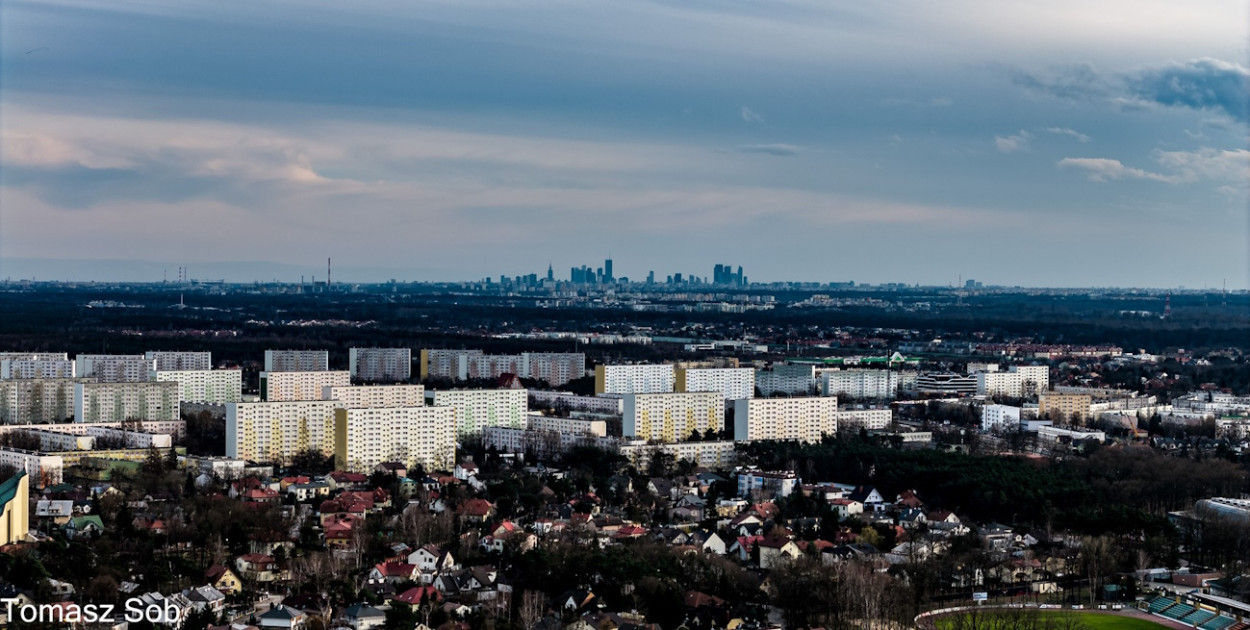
xmin=334 ymin=406 xmax=456 ymax=473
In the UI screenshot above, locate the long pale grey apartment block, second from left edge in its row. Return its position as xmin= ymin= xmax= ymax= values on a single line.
xmin=74 ymin=381 xmax=180 ymax=423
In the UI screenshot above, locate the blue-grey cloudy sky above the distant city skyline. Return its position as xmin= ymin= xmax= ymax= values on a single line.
xmin=0 ymin=0 xmax=1250 ymax=289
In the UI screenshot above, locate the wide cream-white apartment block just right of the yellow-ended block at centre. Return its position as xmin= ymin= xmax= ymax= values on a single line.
xmin=734 ymin=396 xmax=838 ymax=443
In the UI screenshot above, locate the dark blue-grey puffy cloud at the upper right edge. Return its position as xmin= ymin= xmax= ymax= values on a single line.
xmin=1128 ymin=58 xmax=1250 ymax=123
